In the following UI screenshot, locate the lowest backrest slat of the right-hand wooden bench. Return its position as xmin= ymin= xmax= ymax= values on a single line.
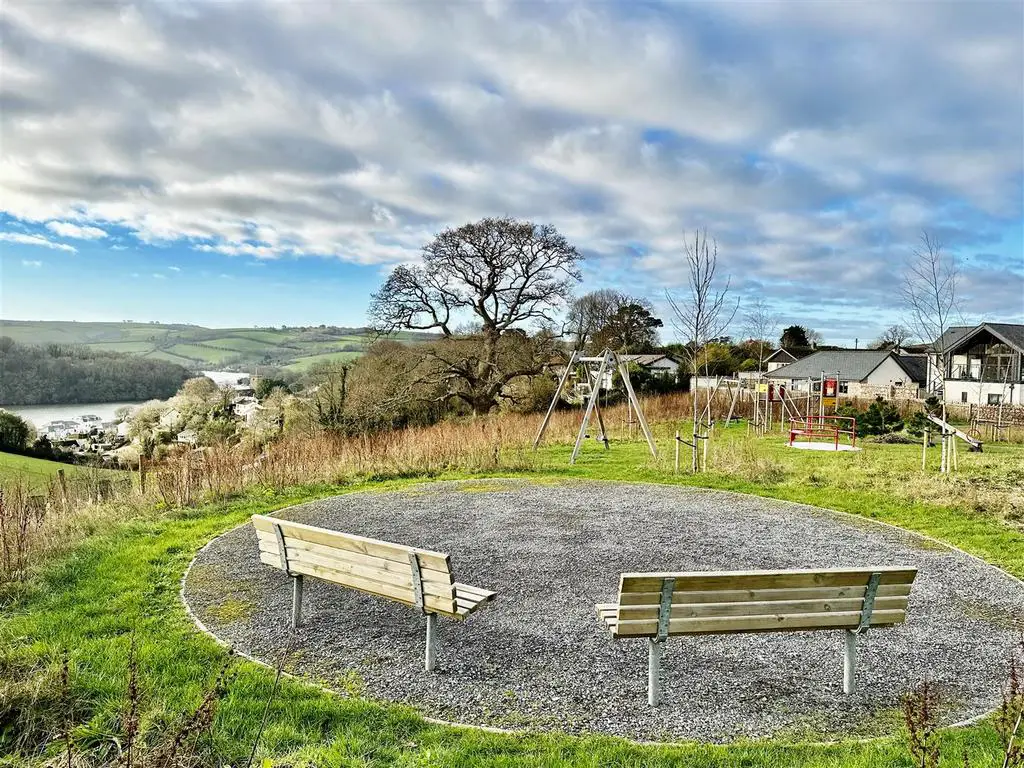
xmin=615 ymin=610 xmax=906 ymax=637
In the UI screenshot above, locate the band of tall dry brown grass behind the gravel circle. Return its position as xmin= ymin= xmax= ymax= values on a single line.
xmin=0 ymin=391 xmax=1020 ymax=597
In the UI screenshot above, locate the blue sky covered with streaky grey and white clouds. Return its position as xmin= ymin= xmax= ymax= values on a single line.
xmin=0 ymin=0 xmax=1024 ymax=344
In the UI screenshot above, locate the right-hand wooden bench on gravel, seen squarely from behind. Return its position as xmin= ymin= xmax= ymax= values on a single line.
xmin=597 ymin=567 xmax=918 ymax=707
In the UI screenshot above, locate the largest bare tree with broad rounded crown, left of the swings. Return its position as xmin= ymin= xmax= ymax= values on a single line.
xmin=369 ymin=218 xmax=583 ymax=414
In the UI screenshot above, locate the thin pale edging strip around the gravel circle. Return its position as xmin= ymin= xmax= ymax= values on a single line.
xmin=178 ymin=475 xmax=1024 ymax=746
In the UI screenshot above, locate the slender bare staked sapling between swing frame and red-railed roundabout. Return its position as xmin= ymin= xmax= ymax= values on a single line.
xmin=665 ymin=229 xmax=739 ymax=472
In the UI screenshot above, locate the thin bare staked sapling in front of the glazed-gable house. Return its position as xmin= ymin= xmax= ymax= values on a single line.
xmin=900 ymin=231 xmax=959 ymax=472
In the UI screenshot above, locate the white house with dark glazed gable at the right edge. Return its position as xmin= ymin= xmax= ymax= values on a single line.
xmin=928 ymin=323 xmax=1024 ymax=406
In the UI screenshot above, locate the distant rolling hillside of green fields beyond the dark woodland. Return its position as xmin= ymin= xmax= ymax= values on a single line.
xmin=0 ymin=319 xmax=434 ymax=372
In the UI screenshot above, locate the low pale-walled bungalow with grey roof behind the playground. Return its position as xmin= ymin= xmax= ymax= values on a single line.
xmin=765 ymin=349 xmax=925 ymax=398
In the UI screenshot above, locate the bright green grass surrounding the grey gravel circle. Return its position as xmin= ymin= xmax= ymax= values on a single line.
xmin=0 ymin=425 xmax=1024 ymax=768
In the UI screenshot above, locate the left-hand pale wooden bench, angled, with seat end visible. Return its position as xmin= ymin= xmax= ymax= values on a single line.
xmin=253 ymin=515 xmax=497 ymax=672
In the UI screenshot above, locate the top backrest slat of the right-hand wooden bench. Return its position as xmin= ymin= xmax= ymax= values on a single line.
xmin=620 ymin=567 xmax=918 ymax=593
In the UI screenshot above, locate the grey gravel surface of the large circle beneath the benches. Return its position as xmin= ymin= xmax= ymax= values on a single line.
xmin=183 ymin=479 xmax=1024 ymax=741
